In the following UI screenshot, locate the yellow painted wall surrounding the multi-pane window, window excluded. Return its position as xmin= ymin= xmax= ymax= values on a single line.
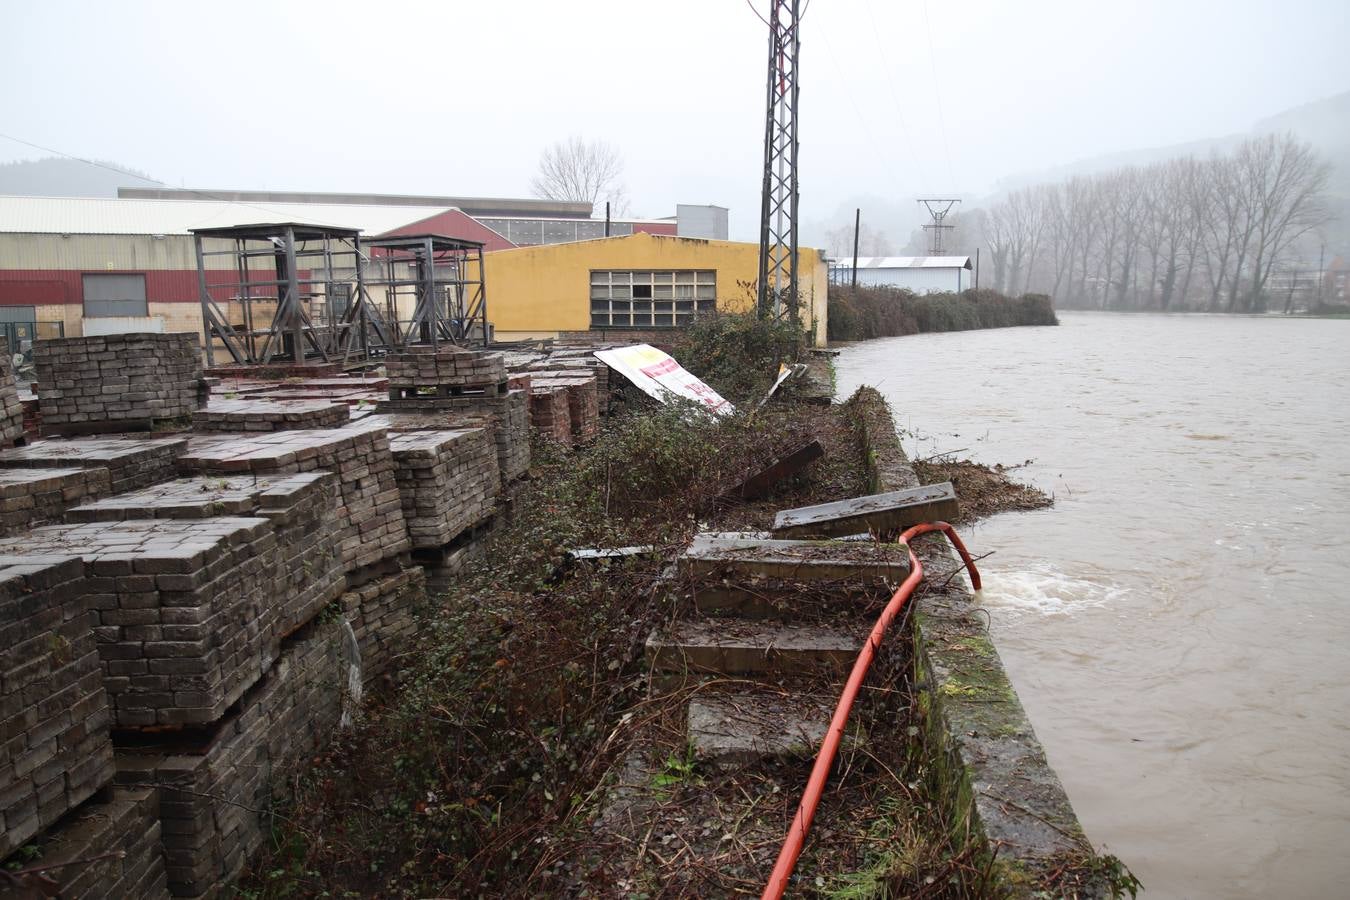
xmin=483 ymin=233 xmax=828 ymax=345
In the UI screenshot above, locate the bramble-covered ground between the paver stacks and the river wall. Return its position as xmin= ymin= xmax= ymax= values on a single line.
xmin=244 ymin=319 xmax=1128 ymax=897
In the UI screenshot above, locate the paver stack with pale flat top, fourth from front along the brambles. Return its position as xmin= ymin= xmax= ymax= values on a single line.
xmin=180 ymin=422 xmax=412 ymax=579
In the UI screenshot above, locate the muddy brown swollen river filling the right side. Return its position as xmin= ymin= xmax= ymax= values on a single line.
xmin=836 ymin=313 xmax=1350 ymax=899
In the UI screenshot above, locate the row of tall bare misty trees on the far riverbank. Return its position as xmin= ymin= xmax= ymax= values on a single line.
xmin=953 ymin=135 xmax=1331 ymax=312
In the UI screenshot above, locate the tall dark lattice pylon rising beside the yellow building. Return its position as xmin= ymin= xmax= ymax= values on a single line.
xmin=757 ymin=0 xmax=802 ymax=322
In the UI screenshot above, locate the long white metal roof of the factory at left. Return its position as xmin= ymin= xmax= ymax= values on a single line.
xmin=0 ymin=197 xmax=452 ymax=235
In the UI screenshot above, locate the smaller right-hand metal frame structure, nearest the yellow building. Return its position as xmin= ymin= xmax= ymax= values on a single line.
xmin=363 ymin=235 xmax=490 ymax=348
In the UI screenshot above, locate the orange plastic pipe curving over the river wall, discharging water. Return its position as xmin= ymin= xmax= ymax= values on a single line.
xmin=763 ymin=522 xmax=980 ymax=900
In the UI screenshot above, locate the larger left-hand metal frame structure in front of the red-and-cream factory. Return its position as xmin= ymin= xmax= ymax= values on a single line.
xmin=192 ymin=223 xmax=392 ymax=366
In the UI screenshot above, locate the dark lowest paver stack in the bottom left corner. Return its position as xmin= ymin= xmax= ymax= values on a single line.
xmin=0 ymin=788 xmax=169 ymax=900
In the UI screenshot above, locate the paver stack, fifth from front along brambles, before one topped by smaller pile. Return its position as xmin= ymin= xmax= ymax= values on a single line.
xmin=389 ymin=428 xmax=501 ymax=549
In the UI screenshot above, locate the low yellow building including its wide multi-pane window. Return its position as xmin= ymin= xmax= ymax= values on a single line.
xmin=483 ymin=233 xmax=828 ymax=347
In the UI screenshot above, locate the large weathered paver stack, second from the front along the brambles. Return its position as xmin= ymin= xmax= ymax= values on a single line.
xmin=0 ymin=518 xmax=278 ymax=729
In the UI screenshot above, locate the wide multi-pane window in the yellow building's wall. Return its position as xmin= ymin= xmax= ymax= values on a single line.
xmin=591 ymin=270 xmax=717 ymax=328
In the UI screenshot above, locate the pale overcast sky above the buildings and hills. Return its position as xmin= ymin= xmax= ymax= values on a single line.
xmin=0 ymin=0 xmax=1350 ymax=237
